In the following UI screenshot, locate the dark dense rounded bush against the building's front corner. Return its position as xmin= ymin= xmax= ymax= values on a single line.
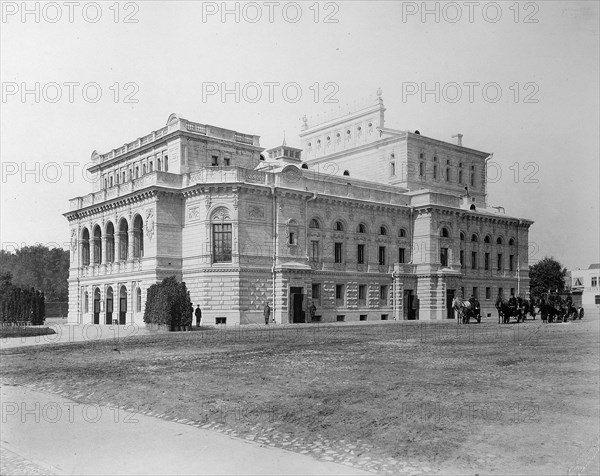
xmin=144 ymin=276 xmax=192 ymax=327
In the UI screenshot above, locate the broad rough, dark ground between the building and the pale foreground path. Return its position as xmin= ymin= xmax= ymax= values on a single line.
xmin=0 ymin=320 xmax=600 ymax=474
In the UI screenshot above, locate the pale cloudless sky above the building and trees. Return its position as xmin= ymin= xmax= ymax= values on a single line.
xmin=0 ymin=1 xmax=600 ymax=268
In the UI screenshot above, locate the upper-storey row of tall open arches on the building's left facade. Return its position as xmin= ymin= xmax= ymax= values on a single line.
xmin=81 ymin=215 xmax=144 ymax=266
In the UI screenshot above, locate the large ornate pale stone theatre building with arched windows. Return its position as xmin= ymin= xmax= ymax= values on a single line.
xmin=65 ymin=92 xmax=533 ymax=325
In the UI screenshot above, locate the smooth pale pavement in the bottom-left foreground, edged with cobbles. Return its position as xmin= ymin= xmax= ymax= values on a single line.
xmin=0 ymin=381 xmax=376 ymax=476
